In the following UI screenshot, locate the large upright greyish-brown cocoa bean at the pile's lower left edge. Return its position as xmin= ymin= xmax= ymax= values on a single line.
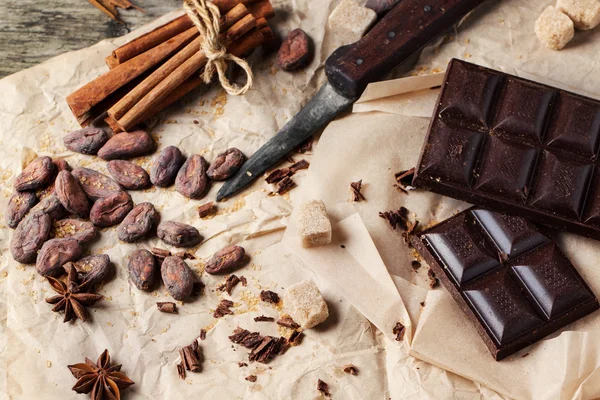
xmin=10 ymin=211 xmax=52 ymax=264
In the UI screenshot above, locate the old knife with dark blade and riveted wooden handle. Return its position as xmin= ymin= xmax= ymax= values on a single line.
xmin=217 ymin=0 xmax=483 ymax=201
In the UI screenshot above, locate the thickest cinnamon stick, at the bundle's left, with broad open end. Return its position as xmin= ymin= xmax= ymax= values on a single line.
xmin=67 ymin=27 xmax=198 ymax=123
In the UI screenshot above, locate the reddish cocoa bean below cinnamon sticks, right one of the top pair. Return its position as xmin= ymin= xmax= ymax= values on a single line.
xmin=98 ymin=131 xmax=156 ymax=160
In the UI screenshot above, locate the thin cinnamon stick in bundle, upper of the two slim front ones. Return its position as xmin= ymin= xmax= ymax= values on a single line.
xmin=108 ymin=4 xmax=249 ymax=121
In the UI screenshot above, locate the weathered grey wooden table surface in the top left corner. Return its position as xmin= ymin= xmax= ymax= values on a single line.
xmin=0 ymin=0 xmax=182 ymax=78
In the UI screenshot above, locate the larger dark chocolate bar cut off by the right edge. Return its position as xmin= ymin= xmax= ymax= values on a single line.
xmin=413 ymin=60 xmax=600 ymax=239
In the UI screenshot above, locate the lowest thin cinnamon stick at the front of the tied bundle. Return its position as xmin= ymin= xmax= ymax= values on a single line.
xmin=118 ymin=15 xmax=256 ymax=131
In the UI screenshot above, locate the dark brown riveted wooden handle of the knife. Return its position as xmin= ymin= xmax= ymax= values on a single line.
xmin=325 ymin=0 xmax=483 ymax=98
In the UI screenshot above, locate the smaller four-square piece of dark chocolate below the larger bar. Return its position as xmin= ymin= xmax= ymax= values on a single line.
xmin=411 ymin=207 xmax=598 ymax=360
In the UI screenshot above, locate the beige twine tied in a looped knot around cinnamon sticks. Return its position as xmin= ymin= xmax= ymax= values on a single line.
xmin=183 ymin=0 xmax=254 ymax=96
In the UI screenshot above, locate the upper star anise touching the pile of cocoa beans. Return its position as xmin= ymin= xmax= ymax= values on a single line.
xmin=46 ymin=268 xmax=103 ymax=322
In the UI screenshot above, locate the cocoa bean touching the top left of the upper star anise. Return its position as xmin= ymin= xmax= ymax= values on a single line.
xmin=35 ymin=239 xmax=81 ymax=276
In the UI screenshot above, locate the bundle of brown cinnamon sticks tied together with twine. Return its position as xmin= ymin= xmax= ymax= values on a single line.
xmin=67 ymin=0 xmax=275 ymax=133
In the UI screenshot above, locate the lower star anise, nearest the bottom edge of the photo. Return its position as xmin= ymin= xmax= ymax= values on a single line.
xmin=68 ymin=350 xmax=135 ymax=400
